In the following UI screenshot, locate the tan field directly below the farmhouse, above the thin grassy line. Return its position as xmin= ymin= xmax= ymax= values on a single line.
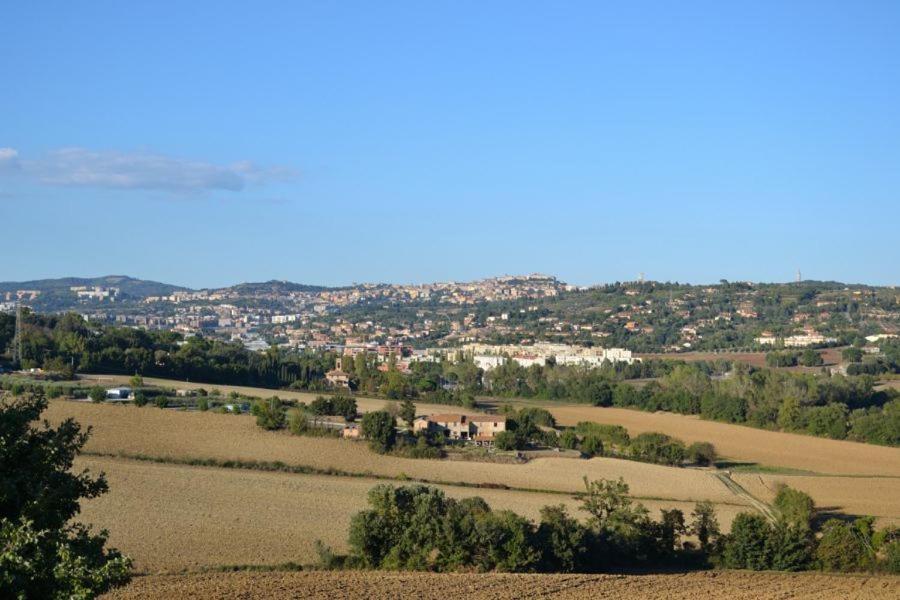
xmin=47 ymin=401 xmax=747 ymax=505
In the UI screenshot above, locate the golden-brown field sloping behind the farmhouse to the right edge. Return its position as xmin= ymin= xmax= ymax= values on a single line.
xmin=77 ymin=376 xmax=900 ymax=477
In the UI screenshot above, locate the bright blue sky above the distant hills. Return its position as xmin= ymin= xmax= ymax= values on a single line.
xmin=0 ymin=1 xmax=900 ymax=287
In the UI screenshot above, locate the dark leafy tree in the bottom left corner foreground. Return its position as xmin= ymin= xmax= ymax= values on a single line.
xmin=0 ymin=395 xmax=131 ymax=598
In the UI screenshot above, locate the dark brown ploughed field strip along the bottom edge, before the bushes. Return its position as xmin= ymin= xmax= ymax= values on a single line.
xmin=104 ymin=571 xmax=900 ymax=600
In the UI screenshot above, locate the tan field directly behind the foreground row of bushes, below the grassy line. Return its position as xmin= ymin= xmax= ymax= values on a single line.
xmin=76 ymin=457 xmax=740 ymax=573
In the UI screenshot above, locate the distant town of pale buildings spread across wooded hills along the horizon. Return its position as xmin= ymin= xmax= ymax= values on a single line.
xmin=0 ymin=274 xmax=900 ymax=358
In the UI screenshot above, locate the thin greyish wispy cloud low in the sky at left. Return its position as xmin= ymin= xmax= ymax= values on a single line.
xmin=0 ymin=148 xmax=294 ymax=193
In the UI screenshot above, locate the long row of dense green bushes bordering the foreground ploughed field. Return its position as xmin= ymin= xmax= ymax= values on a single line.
xmin=338 ymin=478 xmax=900 ymax=573
